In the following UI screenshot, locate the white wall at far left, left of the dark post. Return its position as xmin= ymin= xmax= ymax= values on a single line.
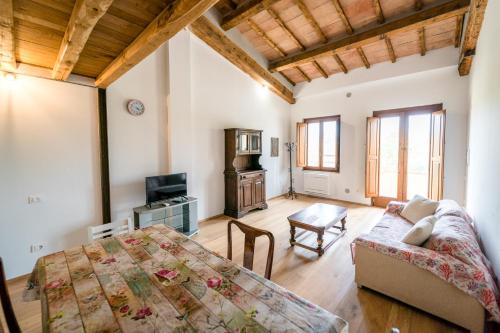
xmin=0 ymin=76 xmax=101 ymax=278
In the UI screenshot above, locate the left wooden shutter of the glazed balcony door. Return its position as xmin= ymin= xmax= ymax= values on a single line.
xmin=365 ymin=117 xmax=380 ymax=198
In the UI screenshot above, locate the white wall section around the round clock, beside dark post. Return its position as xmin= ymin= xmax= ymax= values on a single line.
xmin=106 ymin=46 xmax=168 ymax=220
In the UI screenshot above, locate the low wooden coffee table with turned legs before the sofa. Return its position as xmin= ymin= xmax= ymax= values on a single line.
xmin=288 ymin=203 xmax=347 ymax=256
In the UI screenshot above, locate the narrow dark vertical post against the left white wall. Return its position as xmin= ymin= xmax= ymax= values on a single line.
xmin=98 ymin=88 xmax=111 ymax=224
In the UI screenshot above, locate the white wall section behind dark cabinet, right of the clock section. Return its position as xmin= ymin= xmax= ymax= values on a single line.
xmin=169 ymin=32 xmax=290 ymax=219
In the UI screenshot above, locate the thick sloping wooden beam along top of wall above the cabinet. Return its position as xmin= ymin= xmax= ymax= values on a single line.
xmin=190 ymin=16 xmax=295 ymax=104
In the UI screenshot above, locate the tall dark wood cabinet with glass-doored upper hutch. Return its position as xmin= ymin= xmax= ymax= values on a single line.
xmin=224 ymin=128 xmax=267 ymax=218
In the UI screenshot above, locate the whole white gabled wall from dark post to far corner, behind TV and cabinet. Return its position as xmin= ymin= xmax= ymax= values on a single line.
xmin=107 ymin=30 xmax=290 ymax=219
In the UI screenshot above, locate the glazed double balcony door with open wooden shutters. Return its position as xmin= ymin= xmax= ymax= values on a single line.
xmin=366 ymin=104 xmax=445 ymax=207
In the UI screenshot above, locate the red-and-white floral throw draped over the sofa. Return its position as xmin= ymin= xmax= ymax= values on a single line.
xmin=354 ymin=200 xmax=500 ymax=322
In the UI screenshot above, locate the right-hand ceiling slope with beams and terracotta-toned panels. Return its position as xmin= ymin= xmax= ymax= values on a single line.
xmin=216 ymin=0 xmax=476 ymax=83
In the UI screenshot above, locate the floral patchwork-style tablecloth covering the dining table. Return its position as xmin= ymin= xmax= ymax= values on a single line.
xmin=26 ymin=225 xmax=348 ymax=333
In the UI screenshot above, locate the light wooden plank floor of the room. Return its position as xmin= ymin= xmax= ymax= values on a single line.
xmin=9 ymin=196 xmax=465 ymax=333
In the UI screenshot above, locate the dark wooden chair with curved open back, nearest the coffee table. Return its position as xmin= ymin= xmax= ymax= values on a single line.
xmin=227 ymin=220 xmax=274 ymax=280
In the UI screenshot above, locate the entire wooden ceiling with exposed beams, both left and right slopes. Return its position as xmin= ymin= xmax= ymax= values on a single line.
xmin=0 ymin=0 xmax=487 ymax=103
